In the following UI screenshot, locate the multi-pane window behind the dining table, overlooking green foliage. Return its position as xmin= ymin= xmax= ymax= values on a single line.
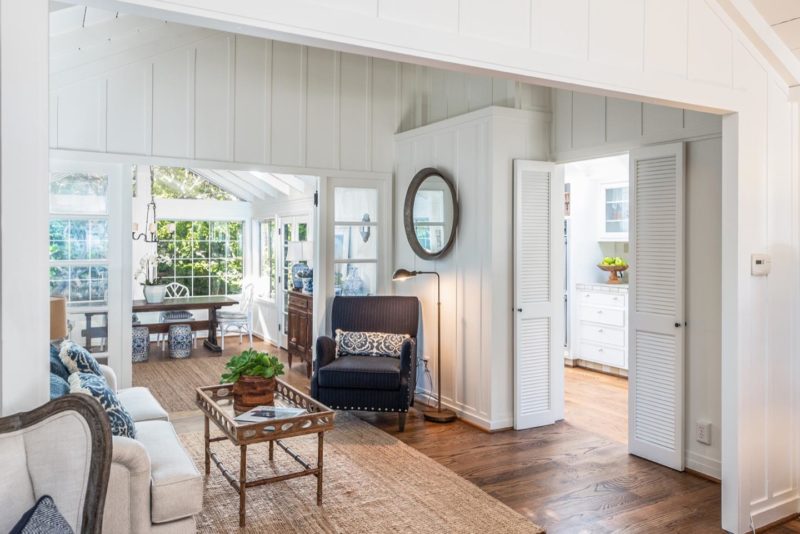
xmin=158 ymin=220 xmax=244 ymax=296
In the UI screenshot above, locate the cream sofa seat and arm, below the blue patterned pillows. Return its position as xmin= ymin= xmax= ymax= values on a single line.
xmin=101 ymin=366 xmax=203 ymax=534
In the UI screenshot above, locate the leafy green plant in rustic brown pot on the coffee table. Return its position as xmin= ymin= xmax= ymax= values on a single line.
xmin=220 ymin=349 xmax=283 ymax=414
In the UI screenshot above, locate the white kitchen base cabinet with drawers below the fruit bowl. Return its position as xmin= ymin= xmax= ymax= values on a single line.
xmin=572 ymin=284 xmax=628 ymax=370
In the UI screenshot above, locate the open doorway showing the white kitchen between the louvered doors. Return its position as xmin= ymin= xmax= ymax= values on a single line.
xmin=562 ymin=152 xmax=630 ymax=444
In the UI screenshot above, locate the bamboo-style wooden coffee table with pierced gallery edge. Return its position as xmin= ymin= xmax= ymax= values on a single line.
xmin=196 ymin=379 xmax=335 ymax=527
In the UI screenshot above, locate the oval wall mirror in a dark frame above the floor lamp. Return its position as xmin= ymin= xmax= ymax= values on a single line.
xmin=403 ymin=167 xmax=458 ymax=260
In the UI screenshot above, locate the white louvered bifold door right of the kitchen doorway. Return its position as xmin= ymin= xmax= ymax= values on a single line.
xmin=628 ymin=143 xmax=684 ymax=471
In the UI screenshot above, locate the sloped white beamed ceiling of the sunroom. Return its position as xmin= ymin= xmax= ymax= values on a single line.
xmin=191 ymin=168 xmax=308 ymax=202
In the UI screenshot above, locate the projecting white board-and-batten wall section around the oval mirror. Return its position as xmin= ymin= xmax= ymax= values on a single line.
xmin=394 ymin=107 xmax=551 ymax=430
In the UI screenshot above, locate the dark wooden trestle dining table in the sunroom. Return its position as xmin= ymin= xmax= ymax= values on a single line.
xmin=132 ymin=295 xmax=239 ymax=352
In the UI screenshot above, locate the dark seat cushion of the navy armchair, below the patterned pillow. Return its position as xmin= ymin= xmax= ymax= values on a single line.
xmin=317 ymin=356 xmax=400 ymax=390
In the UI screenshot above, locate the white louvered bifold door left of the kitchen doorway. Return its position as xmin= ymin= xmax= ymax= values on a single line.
xmin=514 ymin=160 xmax=564 ymax=429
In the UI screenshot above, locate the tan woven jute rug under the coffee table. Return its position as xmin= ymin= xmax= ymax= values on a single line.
xmin=181 ymin=413 xmax=544 ymax=534
